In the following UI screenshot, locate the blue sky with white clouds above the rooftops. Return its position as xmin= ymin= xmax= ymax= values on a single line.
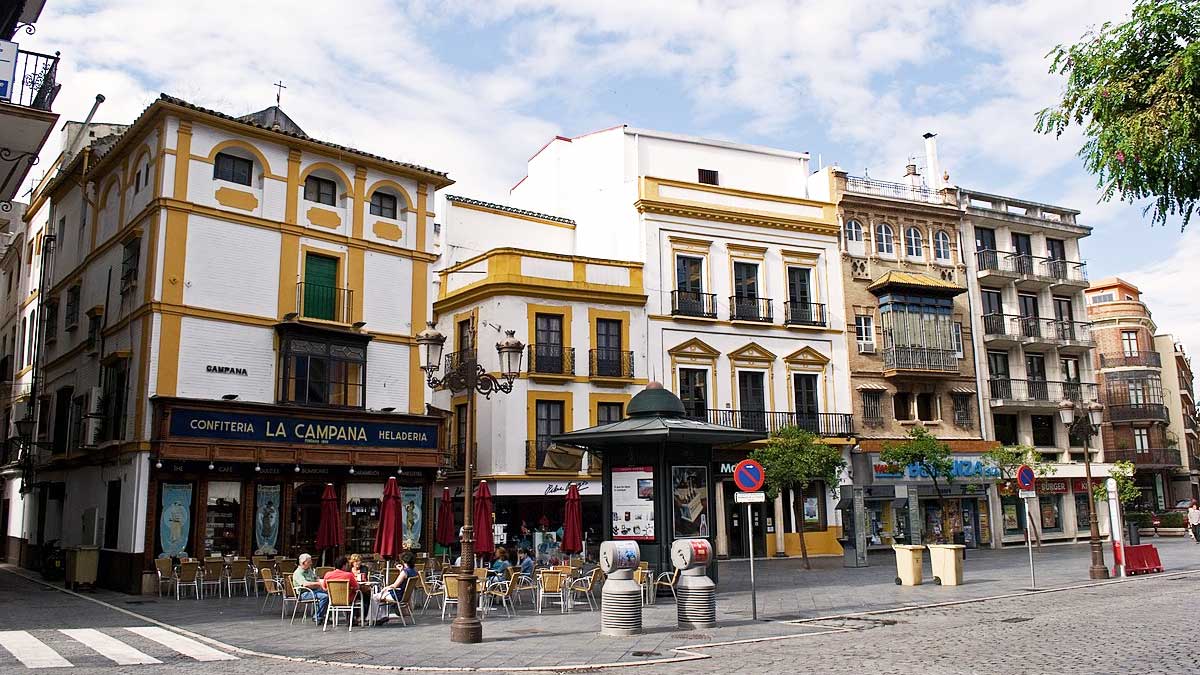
xmin=18 ymin=0 xmax=1200 ymax=351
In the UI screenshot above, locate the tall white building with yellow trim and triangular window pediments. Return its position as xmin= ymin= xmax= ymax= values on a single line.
xmin=511 ymin=126 xmax=853 ymax=556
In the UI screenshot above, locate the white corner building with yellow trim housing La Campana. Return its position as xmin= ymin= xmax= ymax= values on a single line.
xmin=8 ymin=95 xmax=452 ymax=590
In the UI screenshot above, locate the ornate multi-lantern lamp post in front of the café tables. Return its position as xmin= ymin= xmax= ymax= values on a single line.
xmin=416 ymin=319 xmax=524 ymax=643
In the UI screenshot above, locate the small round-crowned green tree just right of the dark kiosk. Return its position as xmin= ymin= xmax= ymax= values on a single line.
xmin=750 ymin=426 xmax=846 ymax=569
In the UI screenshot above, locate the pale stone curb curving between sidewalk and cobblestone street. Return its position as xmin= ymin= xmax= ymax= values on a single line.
xmin=0 ymin=565 xmax=1200 ymax=673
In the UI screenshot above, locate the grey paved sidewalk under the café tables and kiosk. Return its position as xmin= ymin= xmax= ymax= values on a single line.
xmin=18 ymin=538 xmax=1200 ymax=669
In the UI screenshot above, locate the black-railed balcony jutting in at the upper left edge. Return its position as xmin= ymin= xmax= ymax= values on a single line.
xmin=0 ymin=49 xmax=61 ymax=205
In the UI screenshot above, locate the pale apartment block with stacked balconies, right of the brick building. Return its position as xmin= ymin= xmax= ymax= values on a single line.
xmin=959 ymin=189 xmax=1108 ymax=544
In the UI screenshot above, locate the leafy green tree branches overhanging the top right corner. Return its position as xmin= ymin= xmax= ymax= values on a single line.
xmin=1036 ymin=0 xmax=1200 ymax=227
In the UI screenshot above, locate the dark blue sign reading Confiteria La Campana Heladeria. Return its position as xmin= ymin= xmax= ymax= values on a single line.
xmin=170 ymin=408 xmax=438 ymax=448
